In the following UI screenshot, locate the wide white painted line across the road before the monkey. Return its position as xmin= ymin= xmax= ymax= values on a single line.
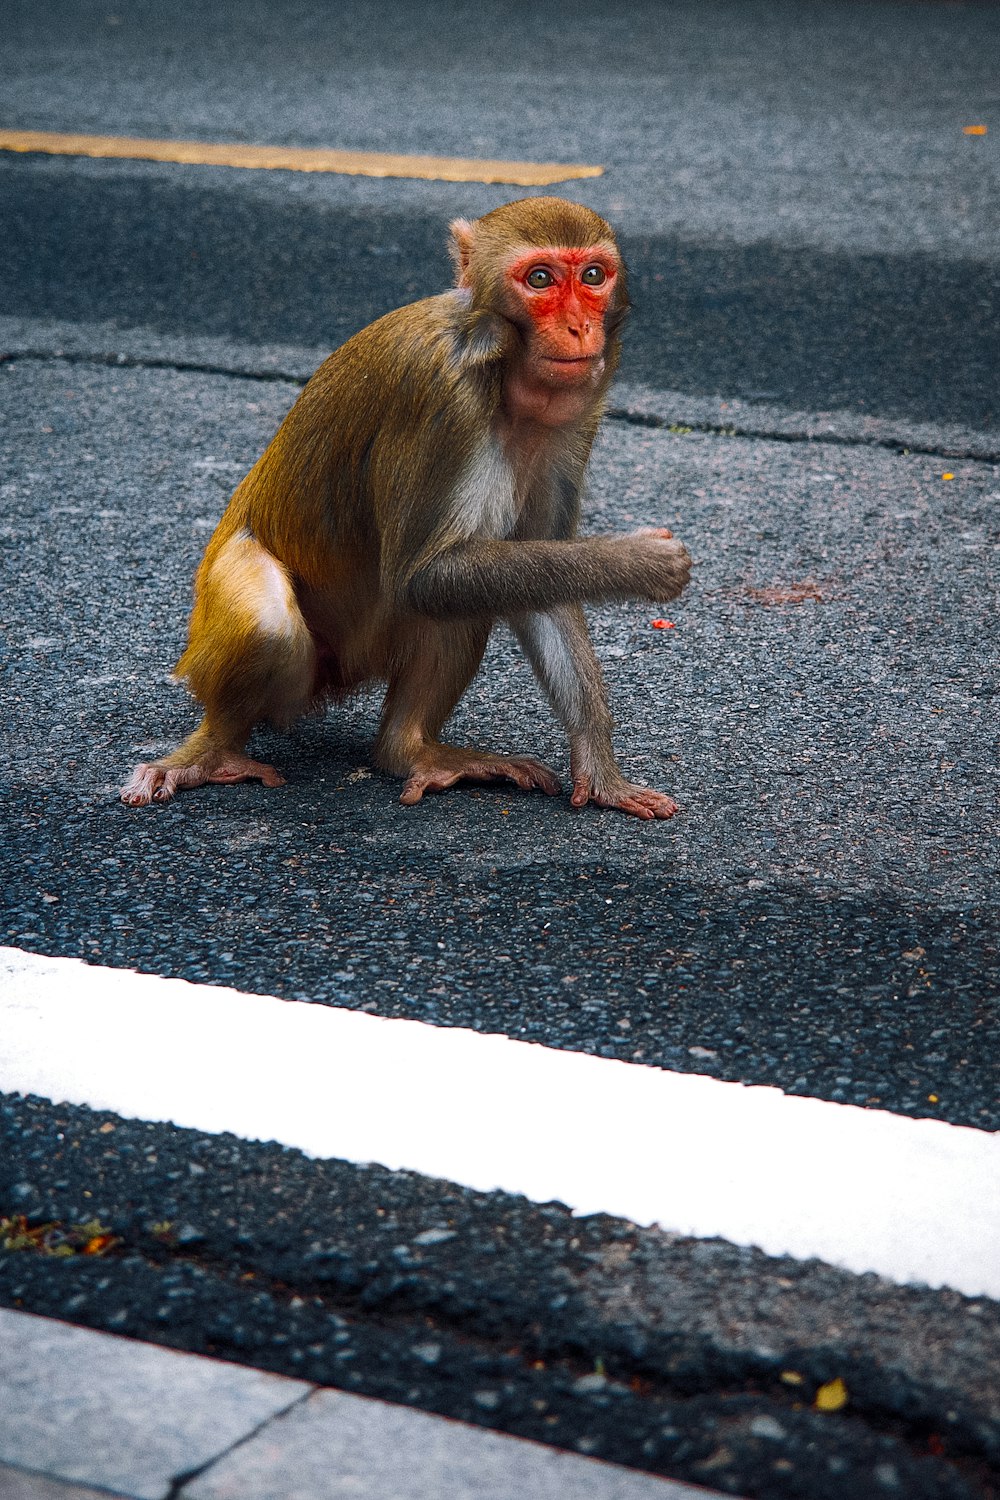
xmin=0 ymin=948 xmax=1000 ymax=1298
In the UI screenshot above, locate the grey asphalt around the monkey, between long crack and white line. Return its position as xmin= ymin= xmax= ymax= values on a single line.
xmin=0 ymin=341 xmax=1000 ymax=1128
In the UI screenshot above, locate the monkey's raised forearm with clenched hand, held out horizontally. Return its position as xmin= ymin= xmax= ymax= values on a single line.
xmin=406 ymin=533 xmax=691 ymax=620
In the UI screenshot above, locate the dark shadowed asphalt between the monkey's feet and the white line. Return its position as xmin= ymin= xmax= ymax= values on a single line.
xmin=3 ymin=792 xmax=1000 ymax=1130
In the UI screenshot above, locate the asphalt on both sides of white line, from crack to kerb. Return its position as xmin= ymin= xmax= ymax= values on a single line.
xmin=0 ymin=340 xmax=1000 ymax=1500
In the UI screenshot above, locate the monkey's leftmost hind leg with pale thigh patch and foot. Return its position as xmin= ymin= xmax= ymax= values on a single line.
xmin=121 ymin=531 xmax=316 ymax=807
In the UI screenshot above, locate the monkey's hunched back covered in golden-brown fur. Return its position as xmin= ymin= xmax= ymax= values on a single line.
xmin=213 ymin=293 xmax=496 ymax=587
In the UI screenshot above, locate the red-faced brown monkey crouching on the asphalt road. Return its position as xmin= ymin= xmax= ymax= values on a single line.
xmin=121 ymin=198 xmax=691 ymax=819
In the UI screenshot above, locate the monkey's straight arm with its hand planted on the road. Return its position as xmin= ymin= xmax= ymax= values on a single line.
xmin=508 ymin=605 xmax=678 ymax=819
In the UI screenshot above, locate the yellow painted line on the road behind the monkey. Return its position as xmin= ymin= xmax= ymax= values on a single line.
xmin=0 ymin=131 xmax=604 ymax=188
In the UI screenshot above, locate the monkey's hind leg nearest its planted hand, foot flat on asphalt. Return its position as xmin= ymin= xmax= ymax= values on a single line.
xmin=375 ymin=621 xmax=559 ymax=806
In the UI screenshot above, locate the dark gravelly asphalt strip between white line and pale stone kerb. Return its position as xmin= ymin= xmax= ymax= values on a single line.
xmin=0 ymin=1100 xmax=1000 ymax=1500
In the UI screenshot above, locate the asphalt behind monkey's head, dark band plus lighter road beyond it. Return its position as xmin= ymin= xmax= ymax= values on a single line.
xmin=0 ymin=0 xmax=1000 ymax=428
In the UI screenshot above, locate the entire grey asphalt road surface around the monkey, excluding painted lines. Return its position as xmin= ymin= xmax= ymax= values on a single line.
xmin=0 ymin=0 xmax=1000 ymax=1500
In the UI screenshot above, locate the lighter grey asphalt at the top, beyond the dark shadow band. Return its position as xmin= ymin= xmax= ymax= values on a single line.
xmin=4 ymin=0 xmax=1000 ymax=261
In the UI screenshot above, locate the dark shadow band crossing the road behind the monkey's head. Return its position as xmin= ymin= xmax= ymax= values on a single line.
xmin=0 ymin=159 xmax=1000 ymax=426
